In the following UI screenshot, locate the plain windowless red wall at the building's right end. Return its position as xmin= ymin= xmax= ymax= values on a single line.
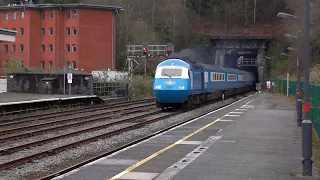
xmin=78 ymin=9 xmax=115 ymax=72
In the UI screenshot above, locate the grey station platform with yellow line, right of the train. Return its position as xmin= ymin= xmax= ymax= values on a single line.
xmin=54 ymin=93 xmax=318 ymax=180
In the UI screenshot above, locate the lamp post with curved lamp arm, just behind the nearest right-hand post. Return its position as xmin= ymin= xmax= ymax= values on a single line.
xmin=277 ymin=12 xmax=302 ymax=126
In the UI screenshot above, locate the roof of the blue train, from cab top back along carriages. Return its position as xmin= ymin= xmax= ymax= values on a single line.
xmin=158 ymin=58 xmax=252 ymax=74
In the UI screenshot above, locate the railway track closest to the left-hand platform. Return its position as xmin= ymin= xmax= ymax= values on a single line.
xmin=0 ymin=98 xmax=155 ymax=127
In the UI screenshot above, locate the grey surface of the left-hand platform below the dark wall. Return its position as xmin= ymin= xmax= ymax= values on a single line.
xmin=0 ymin=92 xmax=95 ymax=104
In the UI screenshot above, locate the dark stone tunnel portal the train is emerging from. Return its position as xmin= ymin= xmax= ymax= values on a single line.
xmin=210 ymin=36 xmax=271 ymax=83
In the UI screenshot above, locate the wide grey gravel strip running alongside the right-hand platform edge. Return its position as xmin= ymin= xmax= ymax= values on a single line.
xmin=0 ymin=94 xmax=250 ymax=180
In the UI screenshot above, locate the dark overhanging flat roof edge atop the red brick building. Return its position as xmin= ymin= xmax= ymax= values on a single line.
xmin=0 ymin=3 xmax=123 ymax=13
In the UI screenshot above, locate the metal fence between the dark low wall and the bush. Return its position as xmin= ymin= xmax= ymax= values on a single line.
xmin=93 ymin=82 xmax=128 ymax=97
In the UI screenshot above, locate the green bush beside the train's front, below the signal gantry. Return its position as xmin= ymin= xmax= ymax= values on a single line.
xmin=129 ymin=76 xmax=154 ymax=100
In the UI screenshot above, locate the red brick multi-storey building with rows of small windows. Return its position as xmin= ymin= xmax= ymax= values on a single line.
xmin=0 ymin=4 xmax=123 ymax=73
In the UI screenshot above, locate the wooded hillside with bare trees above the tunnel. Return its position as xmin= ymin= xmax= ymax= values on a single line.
xmin=0 ymin=0 xmax=320 ymax=82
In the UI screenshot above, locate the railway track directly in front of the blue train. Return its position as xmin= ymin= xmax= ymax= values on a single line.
xmin=0 ymin=110 xmax=181 ymax=170
